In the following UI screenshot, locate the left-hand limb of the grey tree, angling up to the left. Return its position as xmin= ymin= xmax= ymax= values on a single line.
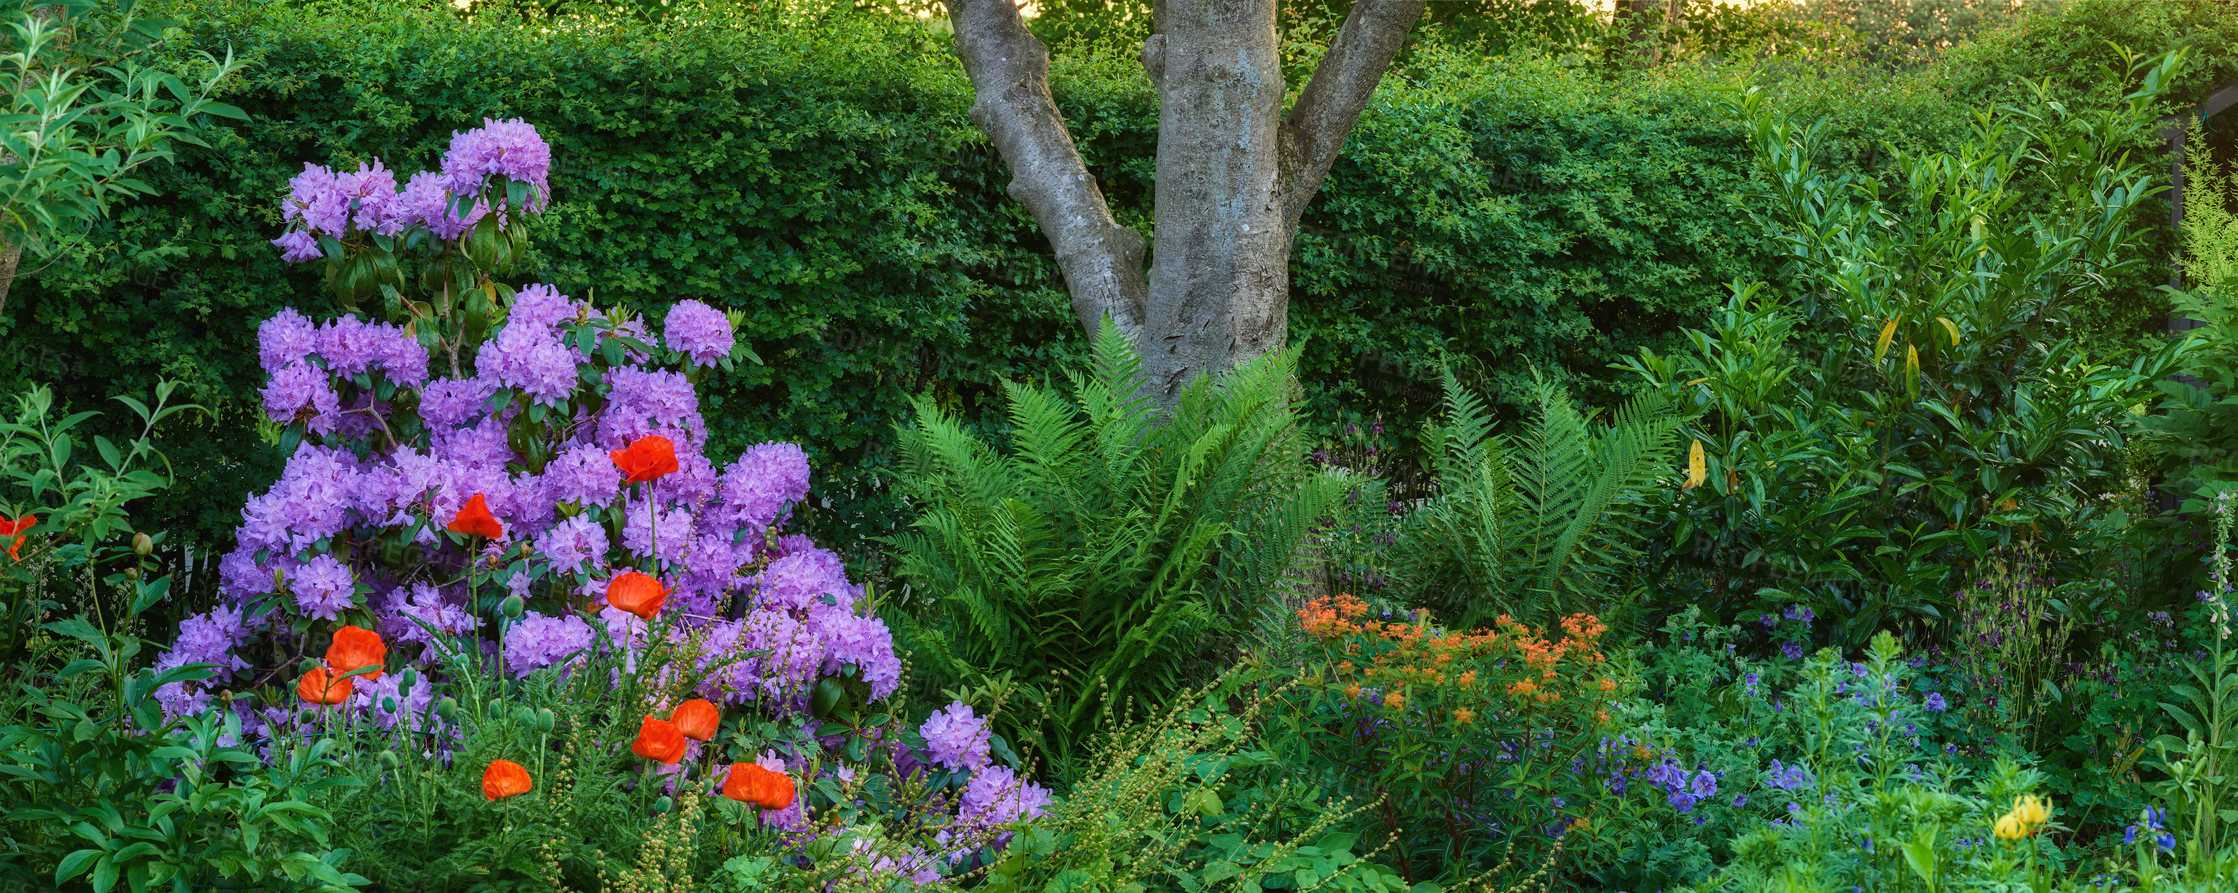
xmin=947 ymin=0 xmax=1154 ymax=345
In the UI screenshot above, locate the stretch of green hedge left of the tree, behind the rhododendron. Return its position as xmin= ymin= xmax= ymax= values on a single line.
xmin=0 ymin=2 xmax=1074 ymax=570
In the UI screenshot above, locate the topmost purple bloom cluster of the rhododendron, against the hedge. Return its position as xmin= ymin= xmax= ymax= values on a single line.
xmin=266 ymin=121 xmax=553 ymax=260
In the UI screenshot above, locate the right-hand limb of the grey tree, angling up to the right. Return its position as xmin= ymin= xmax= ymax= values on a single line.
xmin=1280 ymin=0 xmax=1428 ymax=226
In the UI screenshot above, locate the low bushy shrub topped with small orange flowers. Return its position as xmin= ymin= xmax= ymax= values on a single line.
xmin=1269 ymin=595 xmax=1638 ymax=882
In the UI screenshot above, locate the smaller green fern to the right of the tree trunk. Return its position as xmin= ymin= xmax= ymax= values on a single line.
xmin=1392 ymin=372 xmax=1681 ymax=627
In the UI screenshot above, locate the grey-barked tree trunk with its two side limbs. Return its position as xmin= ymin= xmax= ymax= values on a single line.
xmin=949 ymin=0 xmax=1426 ymax=401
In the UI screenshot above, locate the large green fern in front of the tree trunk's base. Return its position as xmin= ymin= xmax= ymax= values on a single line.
xmin=891 ymin=327 xmax=1350 ymax=761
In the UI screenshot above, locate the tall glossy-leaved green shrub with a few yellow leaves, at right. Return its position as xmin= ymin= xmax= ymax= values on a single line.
xmin=1632 ymin=56 xmax=2180 ymax=640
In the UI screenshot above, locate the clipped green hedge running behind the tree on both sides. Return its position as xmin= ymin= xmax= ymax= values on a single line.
xmin=0 ymin=0 xmax=2234 ymax=559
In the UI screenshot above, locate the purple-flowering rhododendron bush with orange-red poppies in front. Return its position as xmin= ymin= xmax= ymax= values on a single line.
xmin=142 ymin=121 xmax=1050 ymax=880
